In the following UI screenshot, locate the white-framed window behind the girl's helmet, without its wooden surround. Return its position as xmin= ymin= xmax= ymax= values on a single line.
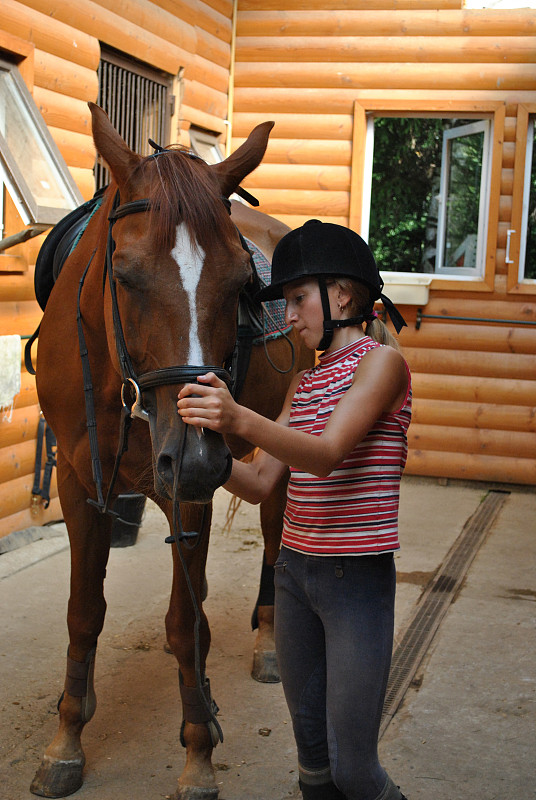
xmin=363 ymin=115 xmax=491 ymax=277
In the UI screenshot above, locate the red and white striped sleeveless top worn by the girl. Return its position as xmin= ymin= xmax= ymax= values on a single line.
xmin=282 ymin=336 xmax=411 ymax=556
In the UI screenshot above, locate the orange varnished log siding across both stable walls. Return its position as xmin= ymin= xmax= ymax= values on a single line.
xmin=0 ymin=0 xmax=536 ymax=536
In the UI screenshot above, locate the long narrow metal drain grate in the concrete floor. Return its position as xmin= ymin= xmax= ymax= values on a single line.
xmin=380 ymin=490 xmax=510 ymax=737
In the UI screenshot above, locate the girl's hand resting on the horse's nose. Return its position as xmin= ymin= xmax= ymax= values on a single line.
xmin=177 ymin=372 xmax=240 ymax=433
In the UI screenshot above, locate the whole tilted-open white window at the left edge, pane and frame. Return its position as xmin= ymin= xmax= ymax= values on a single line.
xmin=0 ymin=55 xmax=83 ymax=231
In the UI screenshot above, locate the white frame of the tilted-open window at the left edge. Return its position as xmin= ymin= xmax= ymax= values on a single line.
xmin=0 ymin=59 xmax=84 ymax=228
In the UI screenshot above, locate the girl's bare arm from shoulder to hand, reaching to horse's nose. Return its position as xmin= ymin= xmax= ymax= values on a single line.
xmin=177 ymin=347 xmax=408 ymax=477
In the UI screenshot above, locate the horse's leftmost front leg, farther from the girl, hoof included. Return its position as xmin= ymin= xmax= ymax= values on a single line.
xmin=30 ymin=454 xmax=111 ymax=797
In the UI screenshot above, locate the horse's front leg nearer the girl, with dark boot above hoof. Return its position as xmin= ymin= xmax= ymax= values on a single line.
xmin=166 ymin=504 xmax=218 ymax=800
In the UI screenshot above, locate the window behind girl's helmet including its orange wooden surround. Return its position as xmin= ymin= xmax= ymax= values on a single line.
xmin=349 ymin=95 xmax=506 ymax=292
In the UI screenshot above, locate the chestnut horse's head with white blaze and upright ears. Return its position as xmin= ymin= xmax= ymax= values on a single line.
xmin=90 ymin=104 xmax=273 ymax=502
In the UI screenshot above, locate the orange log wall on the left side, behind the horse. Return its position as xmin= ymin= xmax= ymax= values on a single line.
xmin=0 ymin=0 xmax=233 ymax=536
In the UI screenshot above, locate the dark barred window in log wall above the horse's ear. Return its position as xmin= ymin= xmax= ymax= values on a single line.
xmin=95 ymin=45 xmax=174 ymax=189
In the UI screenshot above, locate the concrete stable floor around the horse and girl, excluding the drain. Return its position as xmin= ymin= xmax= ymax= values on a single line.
xmin=0 ymin=478 xmax=536 ymax=800
